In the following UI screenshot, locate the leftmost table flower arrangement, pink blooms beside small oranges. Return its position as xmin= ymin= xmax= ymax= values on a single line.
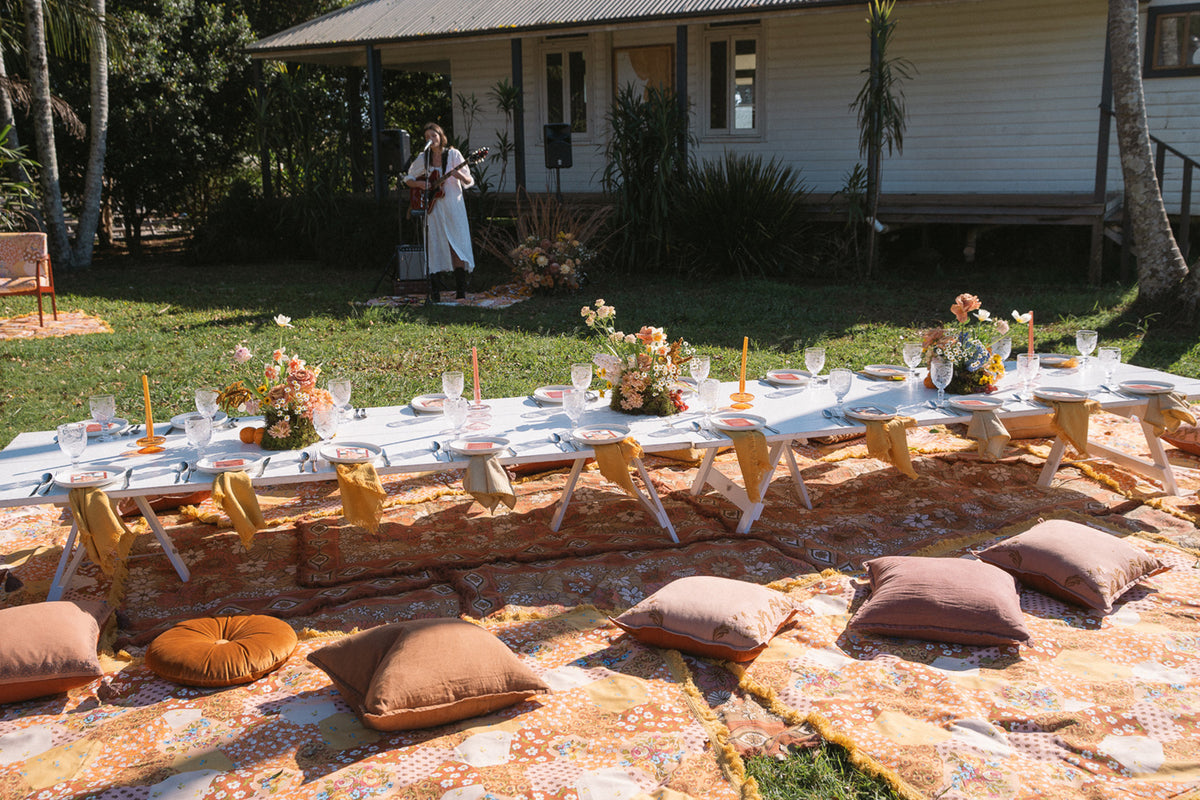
xmin=217 ymin=314 xmax=334 ymax=450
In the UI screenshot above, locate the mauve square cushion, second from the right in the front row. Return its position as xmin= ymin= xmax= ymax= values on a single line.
xmin=850 ymin=555 xmax=1030 ymax=645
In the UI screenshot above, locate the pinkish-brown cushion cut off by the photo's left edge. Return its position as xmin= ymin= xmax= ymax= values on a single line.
xmin=0 ymin=600 xmax=107 ymax=703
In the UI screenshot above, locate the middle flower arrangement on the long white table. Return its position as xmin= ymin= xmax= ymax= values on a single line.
xmin=580 ymin=300 xmax=692 ymax=416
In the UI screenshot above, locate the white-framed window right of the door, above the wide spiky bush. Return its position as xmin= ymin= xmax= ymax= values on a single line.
xmin=704 ymin=29 xmax=762 ymax=136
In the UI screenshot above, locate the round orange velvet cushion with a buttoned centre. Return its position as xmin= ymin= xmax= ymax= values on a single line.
xmin=146 ymin=614 xmax=296 ymax=686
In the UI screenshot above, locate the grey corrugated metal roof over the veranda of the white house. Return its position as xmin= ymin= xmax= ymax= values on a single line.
xmin=250 ymin=0 xmax=852 ymax=54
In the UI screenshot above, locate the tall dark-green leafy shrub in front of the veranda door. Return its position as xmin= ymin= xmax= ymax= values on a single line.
xmin=601 ymin=86 xmax=688 ymax=269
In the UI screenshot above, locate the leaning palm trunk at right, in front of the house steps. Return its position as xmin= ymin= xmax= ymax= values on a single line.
xmin=1109 ymin=0 xmax=1195 ymax=312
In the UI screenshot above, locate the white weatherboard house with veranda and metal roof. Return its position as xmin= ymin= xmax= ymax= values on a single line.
xmin=251 ymin=0 xmax=1200 ymax=271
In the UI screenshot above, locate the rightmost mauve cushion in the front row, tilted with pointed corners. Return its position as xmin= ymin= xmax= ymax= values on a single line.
xmin=977 ymin=519 xmax=1166 ymax=614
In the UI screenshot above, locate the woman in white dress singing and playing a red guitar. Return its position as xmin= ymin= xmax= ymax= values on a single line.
xmin=404 ymin=122 xmax=475 ymax=302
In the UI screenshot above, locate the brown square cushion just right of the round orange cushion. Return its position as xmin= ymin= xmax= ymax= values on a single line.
xmin=308 ymin=618 xmax=550 ymax=730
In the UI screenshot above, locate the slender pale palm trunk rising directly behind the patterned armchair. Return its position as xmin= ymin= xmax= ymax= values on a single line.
xmin=24 ymin=0 xmax=72 ymax=267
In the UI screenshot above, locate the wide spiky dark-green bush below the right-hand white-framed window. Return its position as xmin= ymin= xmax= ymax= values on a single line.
xmin=672 ymin=151 xmax=808 ymax=278
